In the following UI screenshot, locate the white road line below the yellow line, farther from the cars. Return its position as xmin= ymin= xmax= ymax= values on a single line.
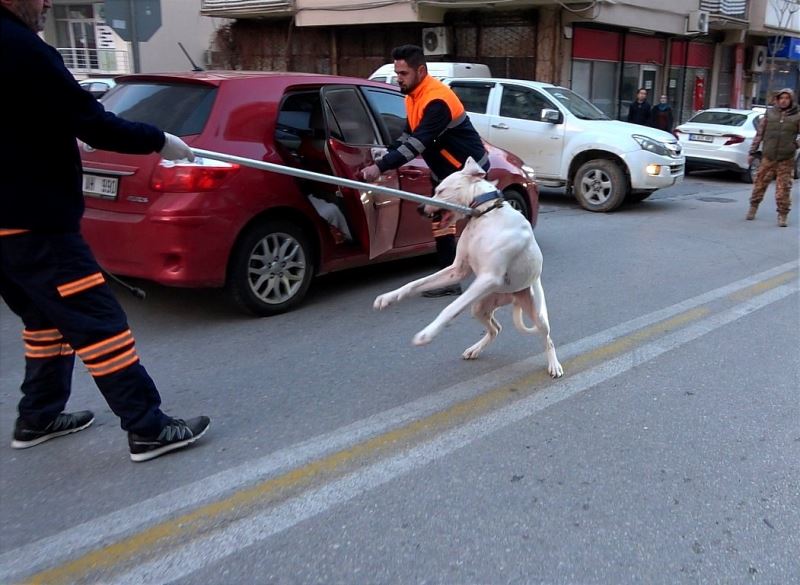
xmin=113 ymin=282 xmax=798 ymax=585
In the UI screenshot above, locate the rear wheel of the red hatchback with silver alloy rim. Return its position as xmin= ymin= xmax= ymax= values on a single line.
xmin=227 ymin=220 xmax=314 ymax=317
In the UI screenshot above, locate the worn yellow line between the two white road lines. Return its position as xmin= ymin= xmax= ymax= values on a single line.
xmin=25 ymin=272 xmax=797 ymax=585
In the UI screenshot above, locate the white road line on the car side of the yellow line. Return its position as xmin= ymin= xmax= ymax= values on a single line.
xmin=0 ymin=261 xmax=798 ymax=582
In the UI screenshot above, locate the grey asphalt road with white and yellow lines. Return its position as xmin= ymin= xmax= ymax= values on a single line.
xmin=0 ymin=174 xmax=800 ymax=585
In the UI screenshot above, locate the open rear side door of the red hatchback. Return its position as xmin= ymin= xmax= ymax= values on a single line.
xmin=320 ymin=85 xmax=401 ymax=259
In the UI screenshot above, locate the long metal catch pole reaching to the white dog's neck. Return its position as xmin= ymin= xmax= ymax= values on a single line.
xmin=191 ymin=148 xmax=475 ymax=217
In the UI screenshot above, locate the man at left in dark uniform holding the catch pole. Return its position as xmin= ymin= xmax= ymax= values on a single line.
xmin=0 ymin=0 xmax=210 ymax=461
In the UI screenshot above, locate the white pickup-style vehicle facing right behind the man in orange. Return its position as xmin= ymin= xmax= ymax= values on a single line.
xmin=445 ymin=78 xmax=685 ymax=211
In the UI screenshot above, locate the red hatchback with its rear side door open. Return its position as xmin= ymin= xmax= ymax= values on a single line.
xmin=81 ymin=71 xmax=538 ymax=315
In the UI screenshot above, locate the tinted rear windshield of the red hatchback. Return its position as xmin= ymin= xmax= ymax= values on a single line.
xmin=103 ymin=82 xmax=217 ymax=136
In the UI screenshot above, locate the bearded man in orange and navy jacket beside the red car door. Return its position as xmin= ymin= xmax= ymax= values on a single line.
xmin=361 ymin=45 xmax=489 ymax=297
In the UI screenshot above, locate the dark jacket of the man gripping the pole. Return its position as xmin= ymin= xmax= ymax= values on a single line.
xmin=0 ymin=7 xmax=164 ymax=232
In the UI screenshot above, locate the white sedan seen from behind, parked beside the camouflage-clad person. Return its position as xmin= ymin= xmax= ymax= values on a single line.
xmin=675 ymin=107 xmax=800 ymax=183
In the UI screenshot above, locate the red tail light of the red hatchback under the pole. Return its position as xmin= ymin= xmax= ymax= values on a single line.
xmin=150 ymin=158 xmax=239 ymax=193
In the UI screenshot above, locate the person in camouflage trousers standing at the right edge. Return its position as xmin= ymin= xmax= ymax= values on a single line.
xmin=746 ymin=87 xmax=800 ymax=227
